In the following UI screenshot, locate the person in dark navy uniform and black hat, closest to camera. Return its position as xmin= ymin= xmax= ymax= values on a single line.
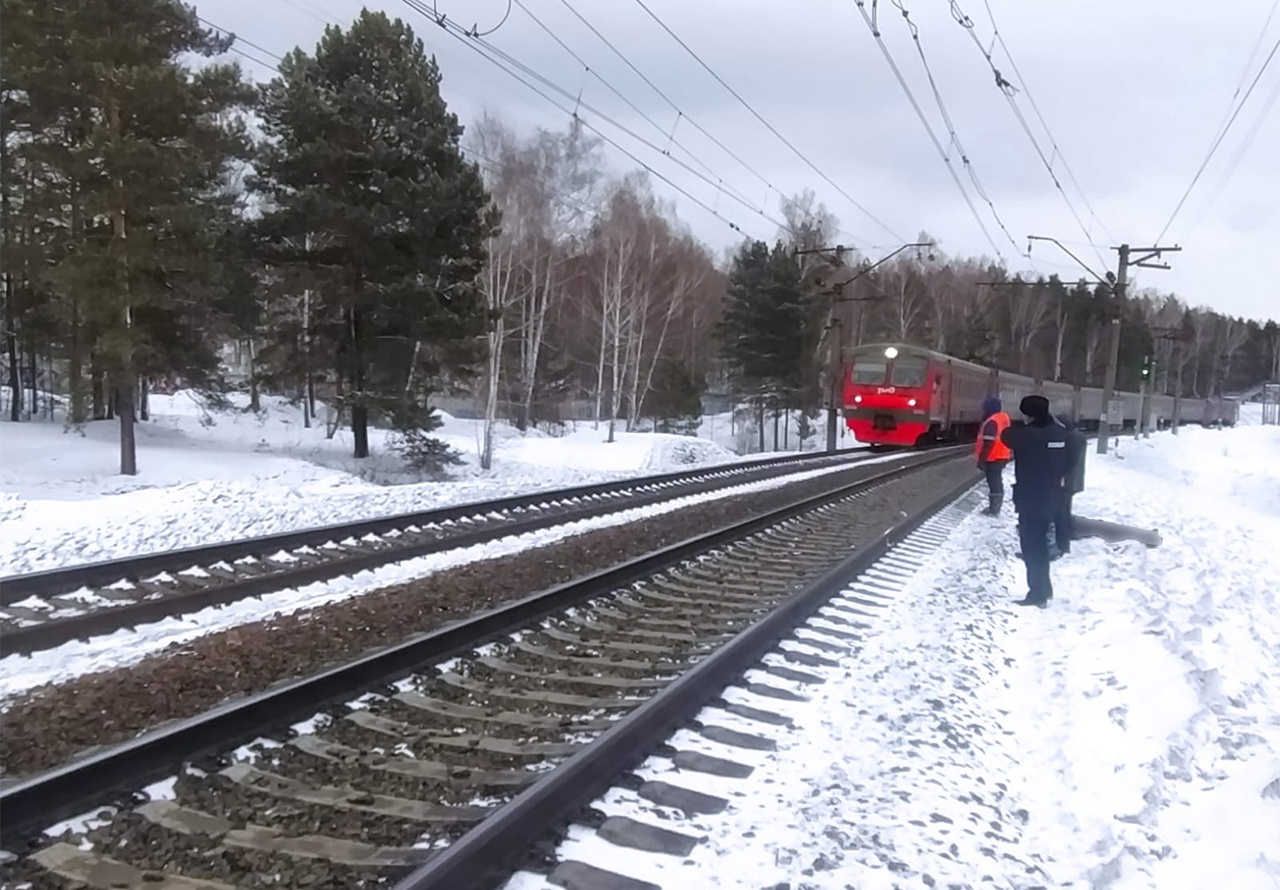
xmin=1002 ymin=396 xmax=1070 ymax=608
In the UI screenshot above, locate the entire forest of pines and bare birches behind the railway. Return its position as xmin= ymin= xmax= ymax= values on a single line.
xmin=0 ymin=0 xmax=1280 ymax=473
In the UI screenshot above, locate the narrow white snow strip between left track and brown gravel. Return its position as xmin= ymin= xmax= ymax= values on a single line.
xmin=0 ymin=455 xmax=904 ymax=700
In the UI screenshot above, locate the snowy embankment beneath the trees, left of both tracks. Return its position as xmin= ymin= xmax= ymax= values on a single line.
xmin=0 ymin=392 xmax=788 ymax=575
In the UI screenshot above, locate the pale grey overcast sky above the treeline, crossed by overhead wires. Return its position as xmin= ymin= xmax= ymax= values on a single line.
xmin=197 ymin=0 xmax=1280 ymax=320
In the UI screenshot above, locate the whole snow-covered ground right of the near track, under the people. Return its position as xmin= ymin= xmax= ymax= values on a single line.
xmin=508 ymin=425 xmax=1280 ymax=890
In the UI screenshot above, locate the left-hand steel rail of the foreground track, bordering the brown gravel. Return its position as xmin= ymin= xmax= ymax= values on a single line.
xmin=0 ymin=446 xmax=972 ymax=849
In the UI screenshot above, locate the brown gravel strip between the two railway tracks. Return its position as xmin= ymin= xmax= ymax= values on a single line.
xmin=0 ymin=460 xmax=972 ymax=777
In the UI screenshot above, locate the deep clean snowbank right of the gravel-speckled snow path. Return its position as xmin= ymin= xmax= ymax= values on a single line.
xmin=992 ymin=425 xmax=1280 ymax=890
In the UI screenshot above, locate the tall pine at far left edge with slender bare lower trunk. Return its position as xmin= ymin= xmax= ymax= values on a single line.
xmin=4 ymin=0 xmax=252 ymax=475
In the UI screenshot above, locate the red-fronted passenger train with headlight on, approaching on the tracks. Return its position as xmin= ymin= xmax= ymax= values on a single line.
xmin=845 ymin=343 xmax=1239 ymax=447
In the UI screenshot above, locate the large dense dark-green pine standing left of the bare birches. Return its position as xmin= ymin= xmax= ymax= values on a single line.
xmin=257 ymin=10 xmax=497 ymax=462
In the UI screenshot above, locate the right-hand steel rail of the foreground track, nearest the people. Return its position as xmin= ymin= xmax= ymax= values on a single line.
xmin=394 ymin=463 xmax=978 ymax=890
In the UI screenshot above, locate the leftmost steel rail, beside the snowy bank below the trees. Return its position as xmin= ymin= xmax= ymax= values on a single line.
xmin=0 ymin=448 xmax=869 ymax=606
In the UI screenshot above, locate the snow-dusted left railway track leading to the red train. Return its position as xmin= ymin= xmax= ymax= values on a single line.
xmin=0 ymin=449 xmax=872 ymax=654
